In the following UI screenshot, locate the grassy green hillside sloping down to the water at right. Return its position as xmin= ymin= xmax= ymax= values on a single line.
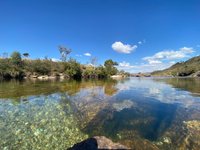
xmin=151 ymin=56 xmax=200 ymax=77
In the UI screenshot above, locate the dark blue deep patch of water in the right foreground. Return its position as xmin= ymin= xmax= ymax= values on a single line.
xmin=85 ymin=100 xmax=177 ymax=140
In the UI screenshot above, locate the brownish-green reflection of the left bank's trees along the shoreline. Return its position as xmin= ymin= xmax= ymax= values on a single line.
xmin=0 ymin=80 xmax=117 ymax=99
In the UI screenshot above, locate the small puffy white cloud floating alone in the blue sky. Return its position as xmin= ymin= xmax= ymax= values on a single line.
xmin=112 ymin=41 xmax=138 ymax=54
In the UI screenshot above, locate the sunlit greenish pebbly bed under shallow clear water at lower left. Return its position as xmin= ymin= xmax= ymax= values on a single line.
xmin=0 ymin=95 xmax=87 ymax=150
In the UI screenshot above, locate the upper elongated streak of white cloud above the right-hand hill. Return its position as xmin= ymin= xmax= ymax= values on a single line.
xmin=143 ymin=47 xmax=195 ymax=64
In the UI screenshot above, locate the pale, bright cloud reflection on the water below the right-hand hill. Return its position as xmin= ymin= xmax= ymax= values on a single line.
xmin=117 ymin=78 xmax=200 ymax=107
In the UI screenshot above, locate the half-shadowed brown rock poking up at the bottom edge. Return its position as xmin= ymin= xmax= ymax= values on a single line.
xmin=68 ymin=136 xmax=129 ymax=150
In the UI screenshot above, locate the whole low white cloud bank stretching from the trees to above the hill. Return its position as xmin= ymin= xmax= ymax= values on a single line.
xmin=118 ymin=47 xmax=195 ymax=73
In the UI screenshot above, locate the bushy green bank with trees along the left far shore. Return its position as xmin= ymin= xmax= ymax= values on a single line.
xmin=0 ymin=50 xmax=127 ymax=79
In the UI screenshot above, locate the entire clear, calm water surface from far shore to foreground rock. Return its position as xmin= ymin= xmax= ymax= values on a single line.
xmin=0 ymin=78 xmax=200 ymax=150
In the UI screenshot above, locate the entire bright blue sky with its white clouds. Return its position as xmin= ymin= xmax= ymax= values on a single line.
xmin=0 ymin=0 xmax=200 ymax=72
